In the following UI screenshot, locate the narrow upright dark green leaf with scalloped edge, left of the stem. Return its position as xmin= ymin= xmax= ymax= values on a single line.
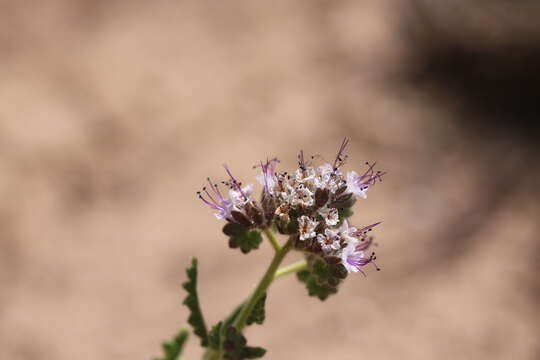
xmin=182 ymin=258 xmax=208 ymax=347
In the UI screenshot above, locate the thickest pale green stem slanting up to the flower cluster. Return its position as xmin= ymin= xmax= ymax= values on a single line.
xmin=233 ymin=239 xmax=292 ymax=332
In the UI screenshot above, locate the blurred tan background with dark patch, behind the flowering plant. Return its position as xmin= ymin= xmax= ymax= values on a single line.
xmin=0 ymin=0 xmax=540 ymax=360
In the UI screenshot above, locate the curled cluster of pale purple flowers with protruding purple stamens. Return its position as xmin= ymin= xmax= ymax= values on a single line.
xmin=198 ymin=139 xmax=384 ymax=273
